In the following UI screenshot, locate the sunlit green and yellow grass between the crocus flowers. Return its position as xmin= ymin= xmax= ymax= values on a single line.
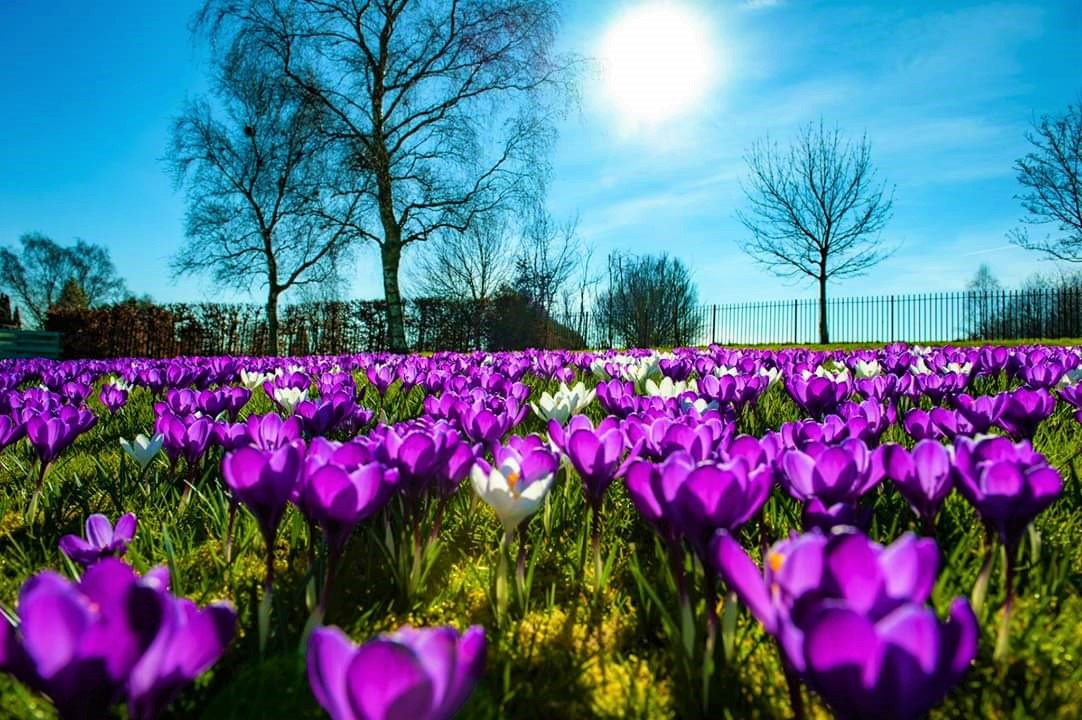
xmin=0 ymin=361 xmax=1082 ymax=720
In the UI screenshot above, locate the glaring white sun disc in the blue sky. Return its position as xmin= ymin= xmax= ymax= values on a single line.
xmin=601 ymin=2 xmax=716 ymax=125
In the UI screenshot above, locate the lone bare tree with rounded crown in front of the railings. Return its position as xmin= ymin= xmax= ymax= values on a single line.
xmin=737 ymin=119 xmax=894 ymax=343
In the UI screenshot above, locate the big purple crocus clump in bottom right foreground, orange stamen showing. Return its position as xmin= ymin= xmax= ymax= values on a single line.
xmin=711 ymin=529 xmax=979 ymax=720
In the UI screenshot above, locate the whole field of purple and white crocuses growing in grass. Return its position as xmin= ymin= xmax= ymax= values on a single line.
xmin=0 ymin=344 xmax=1082 ymax=720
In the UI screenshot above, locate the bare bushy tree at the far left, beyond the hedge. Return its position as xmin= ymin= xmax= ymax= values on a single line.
xmin=0 ymin=233 xmax=127 ymax=327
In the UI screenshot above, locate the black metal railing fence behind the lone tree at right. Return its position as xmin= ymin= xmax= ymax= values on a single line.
xmin=554 ymin=287 xmax=1082 ymax=348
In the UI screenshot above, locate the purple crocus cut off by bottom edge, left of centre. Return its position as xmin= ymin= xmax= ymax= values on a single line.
xmin=307 ymin=626 xmax=485 ymax=720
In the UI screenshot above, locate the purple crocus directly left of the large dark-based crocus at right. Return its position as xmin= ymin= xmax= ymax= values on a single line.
xmin=871 ymin=440 xmax=953 ymax=534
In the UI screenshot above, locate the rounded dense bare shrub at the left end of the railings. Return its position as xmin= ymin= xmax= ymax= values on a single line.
xmin=597 ymin=252 xmax=698 ymax=348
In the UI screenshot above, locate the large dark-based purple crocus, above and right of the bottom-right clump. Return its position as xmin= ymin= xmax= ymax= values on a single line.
xmin=953 ymin=436 xmax=1064 ymax=557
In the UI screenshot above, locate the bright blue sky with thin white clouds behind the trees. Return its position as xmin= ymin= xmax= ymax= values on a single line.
xmin=0 ymin=0 xmax=1082 ymax=303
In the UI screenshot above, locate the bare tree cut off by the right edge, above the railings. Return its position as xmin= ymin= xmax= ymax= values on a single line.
xmin=1010 ymin=96 xmax=1082 ymax=262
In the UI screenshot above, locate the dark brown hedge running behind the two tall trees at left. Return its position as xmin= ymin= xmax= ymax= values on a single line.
xmin=45 ymin=293 xmax=585 ymax=357
